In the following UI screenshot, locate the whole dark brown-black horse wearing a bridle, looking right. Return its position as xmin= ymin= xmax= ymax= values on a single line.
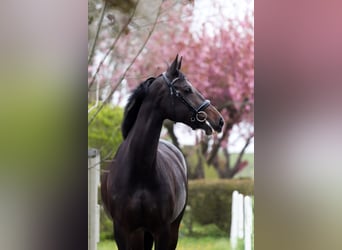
xmin=101 ymin=55 xmax=223 ymax=250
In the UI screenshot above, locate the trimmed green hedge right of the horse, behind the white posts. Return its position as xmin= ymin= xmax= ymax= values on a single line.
xmin=188 ymin=179 xmax=254 ymax=233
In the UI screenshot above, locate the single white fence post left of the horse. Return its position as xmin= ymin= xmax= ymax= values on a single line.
xmin=88 ymin=149 xmax=100 ymax=250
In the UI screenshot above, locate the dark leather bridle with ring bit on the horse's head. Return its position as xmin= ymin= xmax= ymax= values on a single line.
xmin=162 ymin=72 xmax=210 ymax=122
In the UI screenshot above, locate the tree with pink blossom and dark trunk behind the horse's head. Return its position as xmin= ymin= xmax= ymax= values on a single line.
xmin=123 ymin=1 xmax=254 ymax=178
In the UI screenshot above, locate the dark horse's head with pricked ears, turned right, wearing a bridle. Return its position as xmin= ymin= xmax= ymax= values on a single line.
xmin=153 ymin=55 xmax=224 ymax=135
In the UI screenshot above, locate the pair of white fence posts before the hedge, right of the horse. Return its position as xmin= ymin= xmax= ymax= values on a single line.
xmin=230 ymin=191 xmax=254 ymax=250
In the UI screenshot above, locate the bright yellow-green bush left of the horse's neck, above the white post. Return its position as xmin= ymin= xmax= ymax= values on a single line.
xmin=88 ymin=105 xmax=123 ymax=165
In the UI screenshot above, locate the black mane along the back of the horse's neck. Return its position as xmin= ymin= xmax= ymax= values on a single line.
xmin=121 ymin=77 xmax=155 ymax=139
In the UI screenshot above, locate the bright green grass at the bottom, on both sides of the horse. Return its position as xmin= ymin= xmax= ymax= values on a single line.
xmin=97 ymin=236 xmax=230 ymax=250
